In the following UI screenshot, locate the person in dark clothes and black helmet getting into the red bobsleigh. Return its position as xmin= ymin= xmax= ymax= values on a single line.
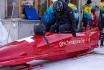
xmin=51 ymin=0 xmax=76 ymax=36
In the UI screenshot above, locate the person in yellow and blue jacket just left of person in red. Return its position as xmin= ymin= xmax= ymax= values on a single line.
xmin=83 ymin=0 xmax=93 ymax=30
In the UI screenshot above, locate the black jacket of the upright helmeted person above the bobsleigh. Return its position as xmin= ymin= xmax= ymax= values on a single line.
xmin=56 ymin=3 xmax=76 ymax=35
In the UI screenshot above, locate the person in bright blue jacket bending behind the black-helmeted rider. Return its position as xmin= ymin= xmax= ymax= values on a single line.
xmin=41 ymin=5 xmax=55 ymax=32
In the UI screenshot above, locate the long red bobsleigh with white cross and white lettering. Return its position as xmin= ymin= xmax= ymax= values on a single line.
xmin=0 ymin=28 xmax=99 ymax=67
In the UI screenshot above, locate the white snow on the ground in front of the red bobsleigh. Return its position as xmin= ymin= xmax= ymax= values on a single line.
xmin=33 ymin=48 xmax=104 ymax=70
